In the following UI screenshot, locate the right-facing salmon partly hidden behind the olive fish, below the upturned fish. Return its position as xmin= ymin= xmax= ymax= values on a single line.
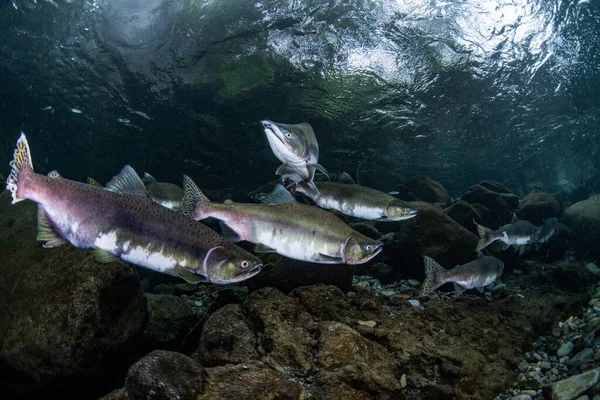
xmin=296 ymin=172 xmax=417 ymax=221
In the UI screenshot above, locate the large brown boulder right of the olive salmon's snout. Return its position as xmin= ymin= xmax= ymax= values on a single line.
xmin=376 ymin=202 xmax=477 ymax=281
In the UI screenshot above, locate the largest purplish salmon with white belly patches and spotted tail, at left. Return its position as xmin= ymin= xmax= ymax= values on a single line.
xmin=6 ymin=134 xmax=262 ymax=283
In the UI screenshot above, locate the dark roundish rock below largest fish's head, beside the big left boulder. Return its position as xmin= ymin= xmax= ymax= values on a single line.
xmin=144 ymin=293 xmax=198 ymax=350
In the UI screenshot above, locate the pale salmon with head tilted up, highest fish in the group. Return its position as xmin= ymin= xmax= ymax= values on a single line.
xmin=260 ymin=120 xmax=329 ymax=194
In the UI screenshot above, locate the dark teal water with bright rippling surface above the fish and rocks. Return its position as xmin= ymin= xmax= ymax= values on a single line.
xmin=0 ymin=0 xmax=600 ymax=195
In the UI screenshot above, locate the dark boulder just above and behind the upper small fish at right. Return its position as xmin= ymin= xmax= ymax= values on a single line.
xmin=461 ymin=181 xmax=519 ymax=229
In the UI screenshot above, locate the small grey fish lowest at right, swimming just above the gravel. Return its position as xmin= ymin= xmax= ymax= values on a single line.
xmin=421 ymin=252 xmax=504 ymax=298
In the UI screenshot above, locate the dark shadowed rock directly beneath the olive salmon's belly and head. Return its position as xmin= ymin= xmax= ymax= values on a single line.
xmin=245 ymin=250 xmax=358 ymax=293
